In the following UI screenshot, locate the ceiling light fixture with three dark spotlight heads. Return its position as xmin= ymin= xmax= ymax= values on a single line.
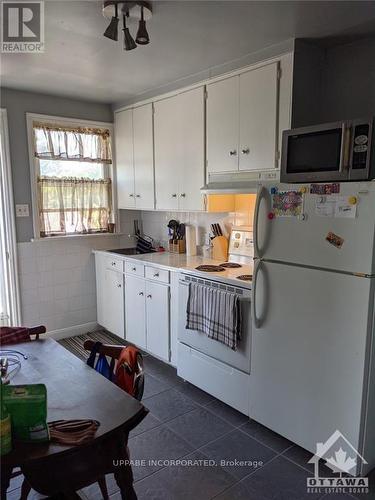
xmin=103 ymin=0 xmax=152 ymax=50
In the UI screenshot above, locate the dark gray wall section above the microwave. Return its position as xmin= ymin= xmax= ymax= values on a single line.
xmin=292 ymin=37 xmax=375 ymax=127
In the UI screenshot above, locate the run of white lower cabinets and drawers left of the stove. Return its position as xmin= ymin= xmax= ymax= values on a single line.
xmin=95 ymin=252 xmax=173 ymax=364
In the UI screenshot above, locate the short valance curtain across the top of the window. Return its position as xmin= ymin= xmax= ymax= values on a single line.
xmin=33 ymin=122 xmax=112 ymax=163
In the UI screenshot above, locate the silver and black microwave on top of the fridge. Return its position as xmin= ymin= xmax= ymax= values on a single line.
xmin=280 ymin=118 xmax=375 ymax=183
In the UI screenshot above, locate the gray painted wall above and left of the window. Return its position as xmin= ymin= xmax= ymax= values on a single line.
xmin=0 ymin=88 xmax=113 ymax=242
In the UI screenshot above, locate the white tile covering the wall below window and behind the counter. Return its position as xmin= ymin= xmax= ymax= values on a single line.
xmin=17 ymin=205 xmax=251 ymax=332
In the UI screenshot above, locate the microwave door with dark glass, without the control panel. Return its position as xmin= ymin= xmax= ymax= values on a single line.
xmin=280 ymin=122 xmax=351 ymax=183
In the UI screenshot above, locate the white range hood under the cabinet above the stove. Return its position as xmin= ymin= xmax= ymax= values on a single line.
xmin=201 ymin=170 xmax=280 ymax=194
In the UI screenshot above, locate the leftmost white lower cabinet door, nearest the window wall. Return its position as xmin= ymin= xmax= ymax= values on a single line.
xmin=101 ymin=269 xmax=125 ymax=338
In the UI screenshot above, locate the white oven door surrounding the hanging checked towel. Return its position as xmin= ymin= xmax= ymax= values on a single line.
xmin=178 ymin=276 xmax=251 ymax=373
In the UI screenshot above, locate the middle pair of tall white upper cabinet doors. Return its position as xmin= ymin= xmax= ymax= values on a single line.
xmin=154 ymin=87 xmax=204 ymax=210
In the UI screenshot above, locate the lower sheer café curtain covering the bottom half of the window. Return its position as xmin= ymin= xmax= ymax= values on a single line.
xmin=38 ymin=177 xmax=112 ymax=237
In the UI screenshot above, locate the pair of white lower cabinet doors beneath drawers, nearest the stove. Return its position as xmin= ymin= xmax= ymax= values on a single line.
xmin=125 ymin=275 xmax=169 ymax=361
